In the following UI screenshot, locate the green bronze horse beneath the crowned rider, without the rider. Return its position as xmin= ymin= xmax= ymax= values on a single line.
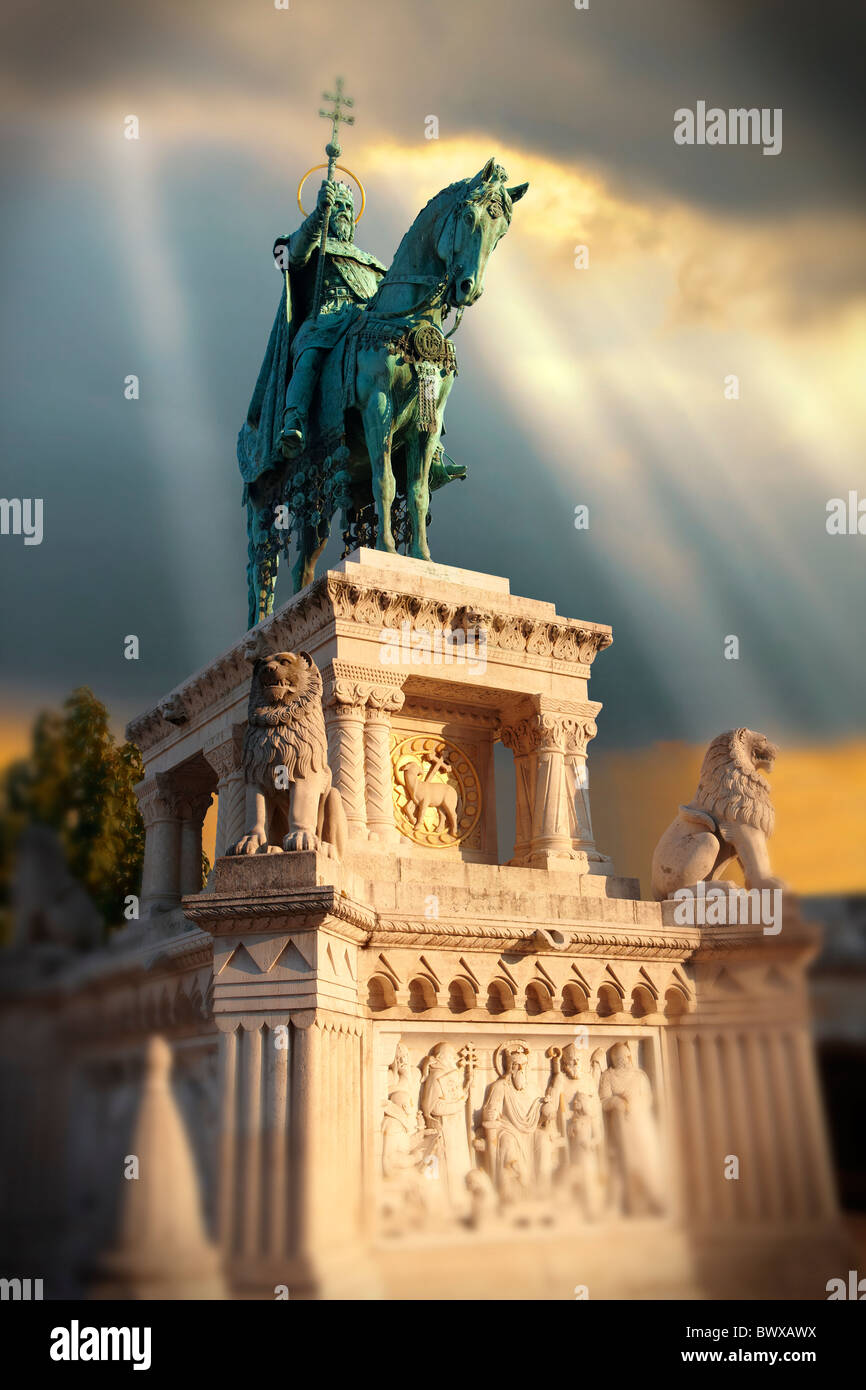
xmin=242 ymin=158 xmax=528 ymax=626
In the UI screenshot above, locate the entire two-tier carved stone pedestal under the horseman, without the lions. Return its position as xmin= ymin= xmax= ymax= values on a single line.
xmin=115 ymin=550 xmax=848 ymax=1300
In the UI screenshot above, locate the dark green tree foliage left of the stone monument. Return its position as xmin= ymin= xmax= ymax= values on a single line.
xmin=0 ymin=688 xmax=145 ymax=926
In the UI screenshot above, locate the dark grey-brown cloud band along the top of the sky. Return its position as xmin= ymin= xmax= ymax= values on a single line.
xmin=3 ymin=0 xmax=866 ymax=215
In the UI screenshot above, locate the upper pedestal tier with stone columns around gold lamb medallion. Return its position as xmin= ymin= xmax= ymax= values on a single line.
xmin=128 ymin=550 xmax=612 ymax=878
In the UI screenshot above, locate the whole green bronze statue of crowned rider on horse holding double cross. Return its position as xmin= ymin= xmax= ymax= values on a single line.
xmin=238 ymin=74 xmax=528 ymax=627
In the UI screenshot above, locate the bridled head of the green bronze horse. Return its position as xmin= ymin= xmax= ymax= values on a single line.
xmin=436 ymin=157 xmax=530 ymax=309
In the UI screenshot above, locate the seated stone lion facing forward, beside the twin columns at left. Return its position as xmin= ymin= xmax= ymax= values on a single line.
xmin=227 ymin=652 xmax=346 ymax=859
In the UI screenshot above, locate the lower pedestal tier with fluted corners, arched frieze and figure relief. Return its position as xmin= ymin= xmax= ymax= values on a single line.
xmin=173 ymin=845 xmax=845 ymax=1298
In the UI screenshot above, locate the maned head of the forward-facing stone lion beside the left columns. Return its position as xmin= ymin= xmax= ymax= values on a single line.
xmin=243 ymin=652 xmax=328 ymax=791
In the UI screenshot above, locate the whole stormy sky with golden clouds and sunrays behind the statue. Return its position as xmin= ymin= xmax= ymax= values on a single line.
xmin=0 ymin=0 xmax=866 ymax=796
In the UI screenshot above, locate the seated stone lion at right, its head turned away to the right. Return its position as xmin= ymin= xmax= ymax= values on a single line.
xmin=652 ymin=728 xmax=783 ymax=901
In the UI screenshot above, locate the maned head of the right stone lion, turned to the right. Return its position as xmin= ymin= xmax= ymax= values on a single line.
xmin=692 ymin=728 xmax=778 ymax=835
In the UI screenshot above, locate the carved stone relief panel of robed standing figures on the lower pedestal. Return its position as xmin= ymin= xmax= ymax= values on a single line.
xmin=374 ymin=1026 xmax=670 ymax=1236
